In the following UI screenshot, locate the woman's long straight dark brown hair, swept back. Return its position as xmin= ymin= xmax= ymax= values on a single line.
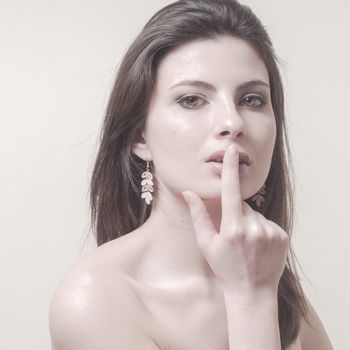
xmin=90 ymin=0 xmax=308 ymax=349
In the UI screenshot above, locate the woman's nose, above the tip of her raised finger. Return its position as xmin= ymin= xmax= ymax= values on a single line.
xmin=214 ymin=103 xmax=246 ymax=139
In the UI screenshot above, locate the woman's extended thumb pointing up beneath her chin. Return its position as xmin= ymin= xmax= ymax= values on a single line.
xmin=182 ymin=191 xmax=217 ymax=252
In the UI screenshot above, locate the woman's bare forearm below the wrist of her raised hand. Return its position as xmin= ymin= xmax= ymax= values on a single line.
xmin=224 ymin=289 xmax=281 ymax=350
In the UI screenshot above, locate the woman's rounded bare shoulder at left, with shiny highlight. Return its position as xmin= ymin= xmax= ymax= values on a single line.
xmin=49 ymin=234 xmax=159 ymax=350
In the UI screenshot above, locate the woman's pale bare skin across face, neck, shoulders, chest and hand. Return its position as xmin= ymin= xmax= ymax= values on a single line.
xmin=50 ymin=38 xmax=332 ymax=350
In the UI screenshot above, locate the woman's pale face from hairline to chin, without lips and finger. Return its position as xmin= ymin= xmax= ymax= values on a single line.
xmin=137 ymin=37 xmax=276 ymax=200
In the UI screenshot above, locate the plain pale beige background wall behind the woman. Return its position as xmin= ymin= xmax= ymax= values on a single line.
xmin=0 ymin=0 xmax=350 ymax=350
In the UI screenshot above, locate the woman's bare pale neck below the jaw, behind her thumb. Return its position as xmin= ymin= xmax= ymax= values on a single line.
xmin=139 ymin=191 xmax=221 ymax=284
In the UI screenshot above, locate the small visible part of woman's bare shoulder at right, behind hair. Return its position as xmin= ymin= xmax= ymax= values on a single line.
xmin=300 ymin=299 xmax=333 ymax=350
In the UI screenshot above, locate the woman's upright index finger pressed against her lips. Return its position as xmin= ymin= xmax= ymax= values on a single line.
xmin=221 ymin=146 xmax=243 ymax=227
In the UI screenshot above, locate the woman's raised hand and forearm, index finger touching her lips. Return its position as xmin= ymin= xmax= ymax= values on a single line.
xmin=185 ymin=146 xmax=289 ymax=350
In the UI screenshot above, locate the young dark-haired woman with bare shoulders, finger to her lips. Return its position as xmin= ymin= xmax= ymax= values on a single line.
xmin=50 ymin=0 xmax=332 ymax=350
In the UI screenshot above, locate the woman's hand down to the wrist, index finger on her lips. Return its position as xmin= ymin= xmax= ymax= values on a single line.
xmin=183 ymin=146 xmax=289 ymax=293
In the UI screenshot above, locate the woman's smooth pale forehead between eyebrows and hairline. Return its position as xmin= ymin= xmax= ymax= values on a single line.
xmin=156 ymin=37 xmax=269 ymax=88
